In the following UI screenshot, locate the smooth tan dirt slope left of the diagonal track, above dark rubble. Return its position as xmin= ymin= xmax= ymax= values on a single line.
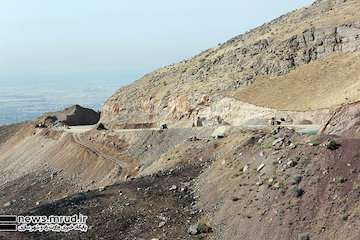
xmin=0 ymin=125 xmax=117 ymax=189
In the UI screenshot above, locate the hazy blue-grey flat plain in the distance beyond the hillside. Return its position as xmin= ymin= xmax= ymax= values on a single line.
xmin=0 ymin=78 xmax=123 ymax=125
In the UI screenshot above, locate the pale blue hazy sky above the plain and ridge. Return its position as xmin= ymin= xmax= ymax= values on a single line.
xmin=0 ymin=0 xmax=312 ymax=82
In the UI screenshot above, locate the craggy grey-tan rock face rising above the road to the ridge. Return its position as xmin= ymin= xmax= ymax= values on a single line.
xmin=101 ymin=0 xmax=360 ymax=125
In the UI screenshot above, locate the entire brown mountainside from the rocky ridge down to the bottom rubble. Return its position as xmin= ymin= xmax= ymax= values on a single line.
xmin=0 ymin=0 xmax=360 ymax=240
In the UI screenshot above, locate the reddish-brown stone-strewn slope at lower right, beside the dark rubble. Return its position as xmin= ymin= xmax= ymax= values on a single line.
xmin=197 ymin=128 xmax=360 ymax=240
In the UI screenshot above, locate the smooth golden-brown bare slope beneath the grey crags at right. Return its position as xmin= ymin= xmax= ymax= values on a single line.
xmin=233 ymin=53 xmax=360 ymax=111
